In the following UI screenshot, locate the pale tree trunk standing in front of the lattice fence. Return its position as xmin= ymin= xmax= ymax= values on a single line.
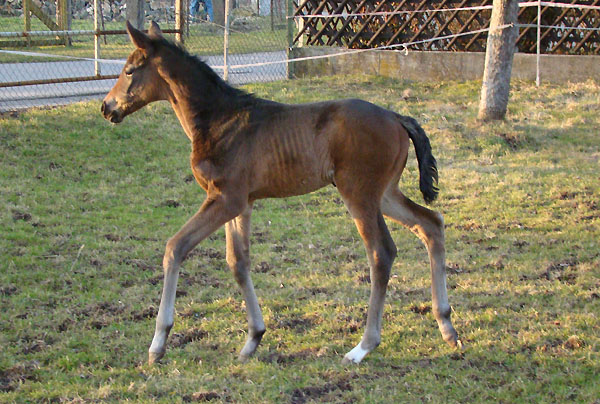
xmin=479 ymin=0 xmax=519 ymax=121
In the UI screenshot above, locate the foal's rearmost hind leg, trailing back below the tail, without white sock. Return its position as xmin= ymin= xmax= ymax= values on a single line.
xmin=381 ymin=183 xmax=462 ymax=347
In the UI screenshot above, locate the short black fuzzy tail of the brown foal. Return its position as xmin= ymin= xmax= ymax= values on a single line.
xmin=398 ymin=115 xmax=439 ymax=203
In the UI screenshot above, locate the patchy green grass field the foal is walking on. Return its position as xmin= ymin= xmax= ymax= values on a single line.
xmin=0 ymin=76 xmax=600 ymax=403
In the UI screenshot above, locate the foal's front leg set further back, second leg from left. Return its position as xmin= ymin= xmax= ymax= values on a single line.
xmin=225 ymin=206 xmax=265 ymax=360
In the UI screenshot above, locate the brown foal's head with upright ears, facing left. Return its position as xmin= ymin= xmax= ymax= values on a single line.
xmin=101 ymin=21 xmax=168 ymax=123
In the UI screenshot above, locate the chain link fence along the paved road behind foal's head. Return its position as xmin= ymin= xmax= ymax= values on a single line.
xmin=0 ymin=0 xmax=288 ymax=111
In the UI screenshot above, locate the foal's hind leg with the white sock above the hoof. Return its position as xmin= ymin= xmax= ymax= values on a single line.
xmin=343 ymin=203 xmax=396 ymax=363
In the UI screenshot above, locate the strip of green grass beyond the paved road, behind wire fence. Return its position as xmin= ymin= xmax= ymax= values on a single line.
xmin=0 ymin=17 xmax=287 ymax=63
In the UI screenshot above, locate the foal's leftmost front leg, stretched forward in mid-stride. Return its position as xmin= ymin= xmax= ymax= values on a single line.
xmin=148 ymin=194 xmax=245 ymax=364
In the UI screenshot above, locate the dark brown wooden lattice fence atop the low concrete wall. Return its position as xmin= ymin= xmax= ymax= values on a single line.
xmin=294 ymin=0 xmax=600 ymax=54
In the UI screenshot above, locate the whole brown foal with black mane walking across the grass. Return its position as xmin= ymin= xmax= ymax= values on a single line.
xmin=102 ymin=23 xmax=461 ymax=363
